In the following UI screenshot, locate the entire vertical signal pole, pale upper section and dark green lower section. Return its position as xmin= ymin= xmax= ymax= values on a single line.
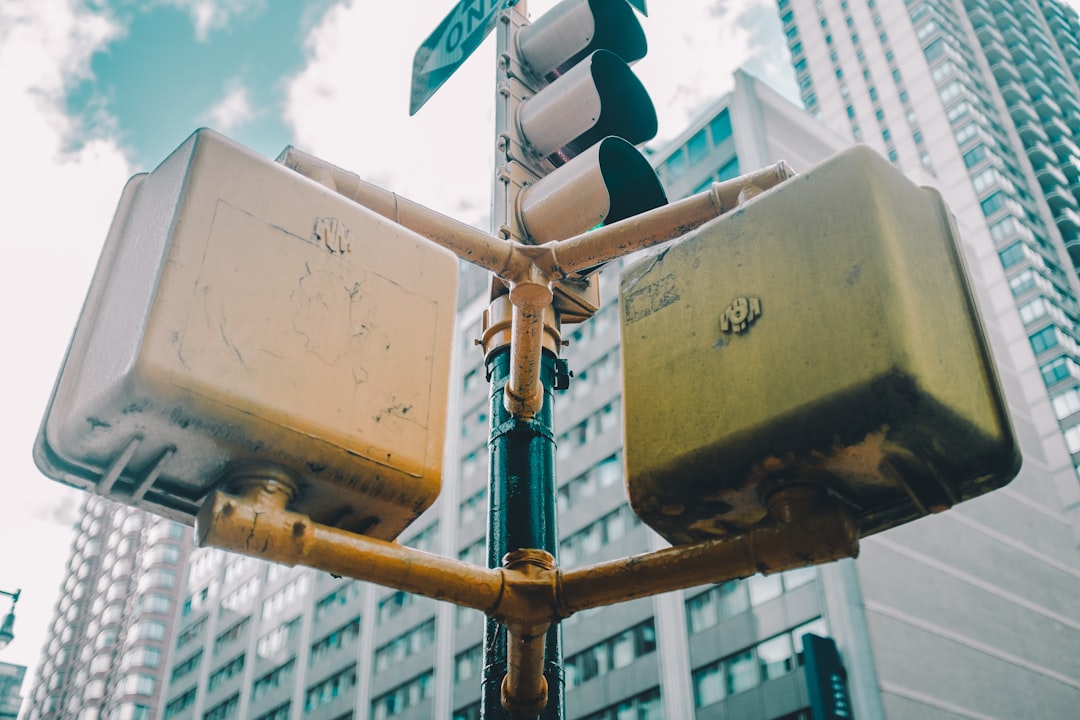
xmin=481 ymin=0 xmax=565 ymax=720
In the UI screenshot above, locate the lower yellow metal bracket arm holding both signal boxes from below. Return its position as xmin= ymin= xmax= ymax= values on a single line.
xmin=195 ymin=467 xmax=859 ymax=718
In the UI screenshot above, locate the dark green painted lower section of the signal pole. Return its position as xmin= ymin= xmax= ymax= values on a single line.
xmin=481 ymin=348 xmax=565 ymax=720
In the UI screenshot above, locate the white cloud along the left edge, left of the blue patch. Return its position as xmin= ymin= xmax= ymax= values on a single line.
xmin=0 ymin=0 xmax=130 ymax=687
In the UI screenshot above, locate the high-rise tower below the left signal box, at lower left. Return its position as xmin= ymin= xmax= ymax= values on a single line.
xmin=24 ymin=495 xmax=191 ymax=720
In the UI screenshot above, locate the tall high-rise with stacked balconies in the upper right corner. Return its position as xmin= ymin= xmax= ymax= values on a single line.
xmin=778 ymin=0 xmax=1080 ymax=490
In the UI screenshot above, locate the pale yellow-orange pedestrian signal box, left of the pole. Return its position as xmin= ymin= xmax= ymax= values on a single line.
xmin=35 ymin=130 xmax=457 ymax=540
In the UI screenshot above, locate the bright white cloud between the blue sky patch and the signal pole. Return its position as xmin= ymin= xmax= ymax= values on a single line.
xmin=285 ymin=0 xmax=495 ymax=221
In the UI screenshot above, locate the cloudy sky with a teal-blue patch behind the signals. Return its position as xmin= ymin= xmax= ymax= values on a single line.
xmin=0 ymin=0 xmax=796 ymax=693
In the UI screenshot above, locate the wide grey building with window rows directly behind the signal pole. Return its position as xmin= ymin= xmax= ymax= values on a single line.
xmin=150 ymin=66 xmax=1080 ymax=720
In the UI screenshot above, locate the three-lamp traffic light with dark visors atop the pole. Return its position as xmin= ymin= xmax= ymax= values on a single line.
xmin=496 ymin=0 xmax=666 ymax=322
